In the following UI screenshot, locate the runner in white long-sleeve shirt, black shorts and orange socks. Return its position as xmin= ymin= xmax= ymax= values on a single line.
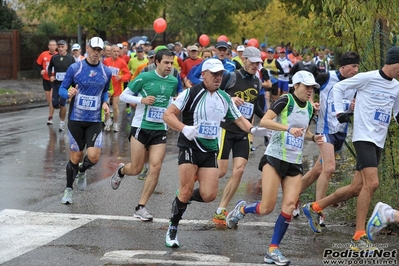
xmin=304 ymin=46 xmax=399 ymax=251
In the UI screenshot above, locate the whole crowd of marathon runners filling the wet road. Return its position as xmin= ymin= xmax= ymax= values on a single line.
xmin=37 ymin=37 xmax=399 ymax=265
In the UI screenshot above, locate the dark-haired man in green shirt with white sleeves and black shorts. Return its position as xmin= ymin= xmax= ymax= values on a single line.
xmin=111 ymin=49 xmax=178 ymax=221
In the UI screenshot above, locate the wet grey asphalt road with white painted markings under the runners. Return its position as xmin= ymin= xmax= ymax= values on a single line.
xmin=0 ymin=105 xmax=397 ymax=266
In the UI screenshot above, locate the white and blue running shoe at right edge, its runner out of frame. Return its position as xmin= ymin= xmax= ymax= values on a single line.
xmin=366 ymin=202 xmax=392 ymax=241
